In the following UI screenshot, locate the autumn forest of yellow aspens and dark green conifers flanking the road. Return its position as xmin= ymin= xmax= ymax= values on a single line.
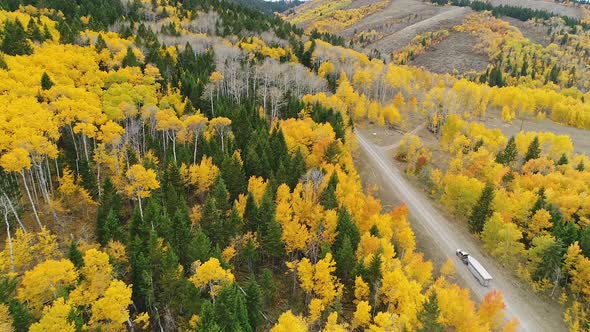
xmin=0 ymin=0 xmax=590 ymax=332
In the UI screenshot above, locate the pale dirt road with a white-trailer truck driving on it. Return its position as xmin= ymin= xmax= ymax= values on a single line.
xmin=356 ymin=131 xmax=566 ymax=332
